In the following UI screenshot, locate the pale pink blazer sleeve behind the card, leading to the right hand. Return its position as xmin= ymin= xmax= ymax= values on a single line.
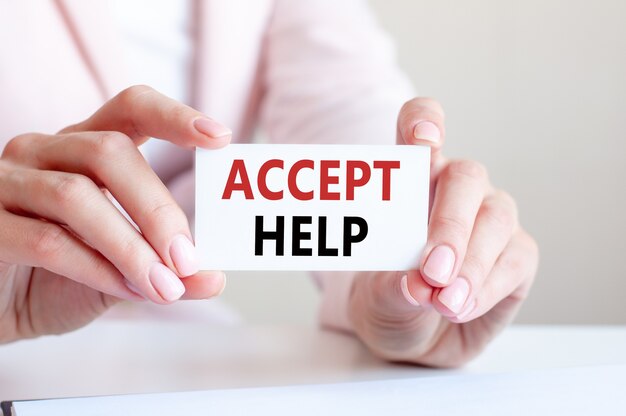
xmin=261 ymin=0 xmax=414 ymax=331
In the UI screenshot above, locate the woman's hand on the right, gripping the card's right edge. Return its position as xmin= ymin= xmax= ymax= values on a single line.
xmin=349 ymin=98 xmax=538 ymax=367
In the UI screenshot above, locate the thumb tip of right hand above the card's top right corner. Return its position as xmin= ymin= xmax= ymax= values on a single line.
xmin=397 ymin=97 xmax=445 ymax=163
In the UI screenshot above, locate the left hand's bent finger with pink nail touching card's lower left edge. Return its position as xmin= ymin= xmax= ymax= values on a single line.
xmin=4 ymin=132 xmax=198 ymax=277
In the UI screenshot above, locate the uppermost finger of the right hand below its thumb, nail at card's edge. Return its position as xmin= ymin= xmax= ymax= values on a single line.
xmin=420 ymin=160 xmax=489 ymax=287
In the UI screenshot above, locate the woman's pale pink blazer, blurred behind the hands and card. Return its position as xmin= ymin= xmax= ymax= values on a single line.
xmin=0 ymin=0 xmax=413 ymax=329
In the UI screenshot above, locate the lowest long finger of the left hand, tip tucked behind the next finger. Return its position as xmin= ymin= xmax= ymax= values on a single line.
xmin=0 ymin=210 xmax=141 ymax=301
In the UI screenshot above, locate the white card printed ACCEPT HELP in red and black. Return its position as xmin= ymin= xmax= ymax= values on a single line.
xmin=195 ymin=144 xmax=430 ymax=271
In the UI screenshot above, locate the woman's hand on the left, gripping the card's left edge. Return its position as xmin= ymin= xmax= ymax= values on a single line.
xmin=0 ymin=86 xmax=231 ymax=342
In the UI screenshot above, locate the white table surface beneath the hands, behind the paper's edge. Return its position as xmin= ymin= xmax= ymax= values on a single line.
xmin=0 ymin=320 xmax=626 ymax=400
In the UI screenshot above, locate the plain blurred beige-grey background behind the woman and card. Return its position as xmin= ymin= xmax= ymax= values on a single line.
xmin=217 ymin=0 xmax=626 ymax=323
